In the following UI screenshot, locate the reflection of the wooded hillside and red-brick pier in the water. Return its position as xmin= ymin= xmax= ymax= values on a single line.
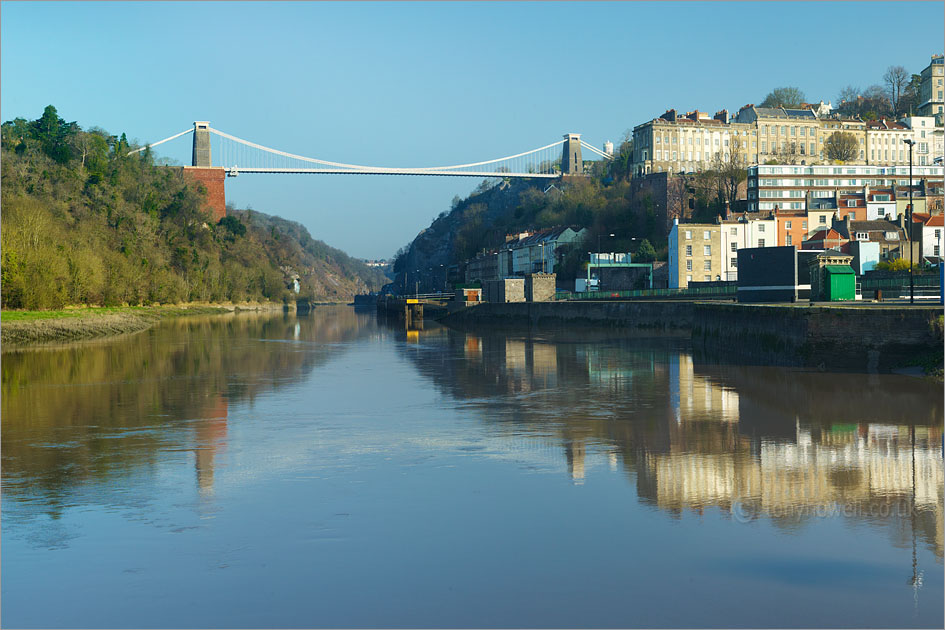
xmin=2 ymin=309 xmax=375 ymax=517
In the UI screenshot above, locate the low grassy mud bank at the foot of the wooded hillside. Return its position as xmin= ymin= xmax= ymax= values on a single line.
xmin=0 ymin=303 xmax=282 ymax=349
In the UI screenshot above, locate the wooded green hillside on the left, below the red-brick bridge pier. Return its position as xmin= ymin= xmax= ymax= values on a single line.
xmin=0 ymin=105 xmax=386 ymax=309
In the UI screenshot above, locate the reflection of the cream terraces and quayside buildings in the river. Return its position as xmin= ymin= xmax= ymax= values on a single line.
xmin=410 ymin=330 xmax=945 ymax=558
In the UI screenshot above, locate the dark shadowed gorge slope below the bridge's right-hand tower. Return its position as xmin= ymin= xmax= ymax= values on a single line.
xmin=388 ymin=180 xmax=547 ymax=293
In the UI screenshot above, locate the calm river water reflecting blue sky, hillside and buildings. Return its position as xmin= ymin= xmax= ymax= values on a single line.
xmin=0 ymin=307 xmax=943 ymax=628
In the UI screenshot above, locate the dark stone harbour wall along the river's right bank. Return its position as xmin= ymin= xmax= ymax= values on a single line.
xmin=442 ymin=300 xmax=943 ymax=372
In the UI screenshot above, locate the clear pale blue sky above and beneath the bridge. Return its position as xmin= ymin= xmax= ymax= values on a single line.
xmin=0 ymin=1 xmax=945 ymax=258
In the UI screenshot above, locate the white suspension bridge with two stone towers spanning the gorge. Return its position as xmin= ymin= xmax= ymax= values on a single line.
xmin=129 ymin=121 xmax=613 ymax=220
